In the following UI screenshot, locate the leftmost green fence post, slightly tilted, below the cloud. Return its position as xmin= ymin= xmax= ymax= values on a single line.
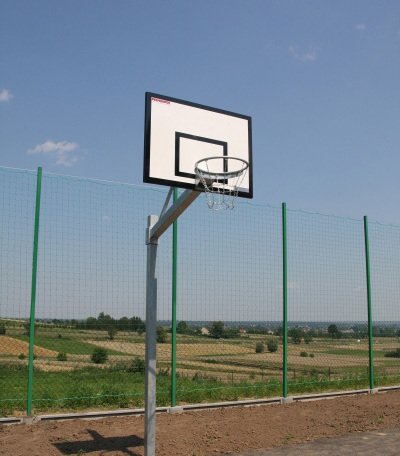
xmin=27 ymin=168 xmax=42 ymax=415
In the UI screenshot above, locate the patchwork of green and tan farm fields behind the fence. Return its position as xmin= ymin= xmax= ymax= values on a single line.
xmin=0 ymin=324 xmax=400 ymax=415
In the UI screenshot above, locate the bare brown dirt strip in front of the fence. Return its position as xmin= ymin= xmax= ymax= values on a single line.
xmin=0 ymin=391 xmax=400 ymax=456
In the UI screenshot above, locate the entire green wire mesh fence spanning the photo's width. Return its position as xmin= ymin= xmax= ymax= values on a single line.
xmin=0 ymin=168 xmax=400 ymax=415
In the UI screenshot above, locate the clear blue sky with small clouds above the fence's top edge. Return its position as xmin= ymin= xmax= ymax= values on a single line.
xmin=0 ymin=0 xmax=400 ymax=224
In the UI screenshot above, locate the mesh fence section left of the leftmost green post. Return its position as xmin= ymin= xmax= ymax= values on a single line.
xmin=0 ymin=168 xmax=36 ymax=411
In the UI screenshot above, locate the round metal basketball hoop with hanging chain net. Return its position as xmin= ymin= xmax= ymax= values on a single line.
xmin=194 ymin=156 xmax=249 ymax=211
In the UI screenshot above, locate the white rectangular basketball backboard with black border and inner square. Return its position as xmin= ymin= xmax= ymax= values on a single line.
xmin=143 ymin=92 xmax=253 ymax=198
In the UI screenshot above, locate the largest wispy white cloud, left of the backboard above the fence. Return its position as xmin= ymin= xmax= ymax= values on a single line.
xmin=27 ymin=140 xmax=82 ymax=167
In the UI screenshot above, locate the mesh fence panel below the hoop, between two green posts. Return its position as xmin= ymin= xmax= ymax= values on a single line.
xmin=173 ymin=197 xmax=282 ymax=402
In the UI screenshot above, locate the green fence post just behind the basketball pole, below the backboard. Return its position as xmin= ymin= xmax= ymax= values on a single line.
xmin=171 ymin=187 xmax=178 ymax=407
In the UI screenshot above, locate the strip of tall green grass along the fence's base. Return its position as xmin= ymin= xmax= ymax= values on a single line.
xmin=0 ymin=363 xmax=400 ymax=415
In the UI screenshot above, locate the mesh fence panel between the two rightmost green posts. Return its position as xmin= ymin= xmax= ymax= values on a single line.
xmin=287 ymin=210 xmax=369 ymax=394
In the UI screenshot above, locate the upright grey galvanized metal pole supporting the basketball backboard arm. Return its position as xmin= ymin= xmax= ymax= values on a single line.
xmin=144 ymin=215 xmax=158 ymax=456
